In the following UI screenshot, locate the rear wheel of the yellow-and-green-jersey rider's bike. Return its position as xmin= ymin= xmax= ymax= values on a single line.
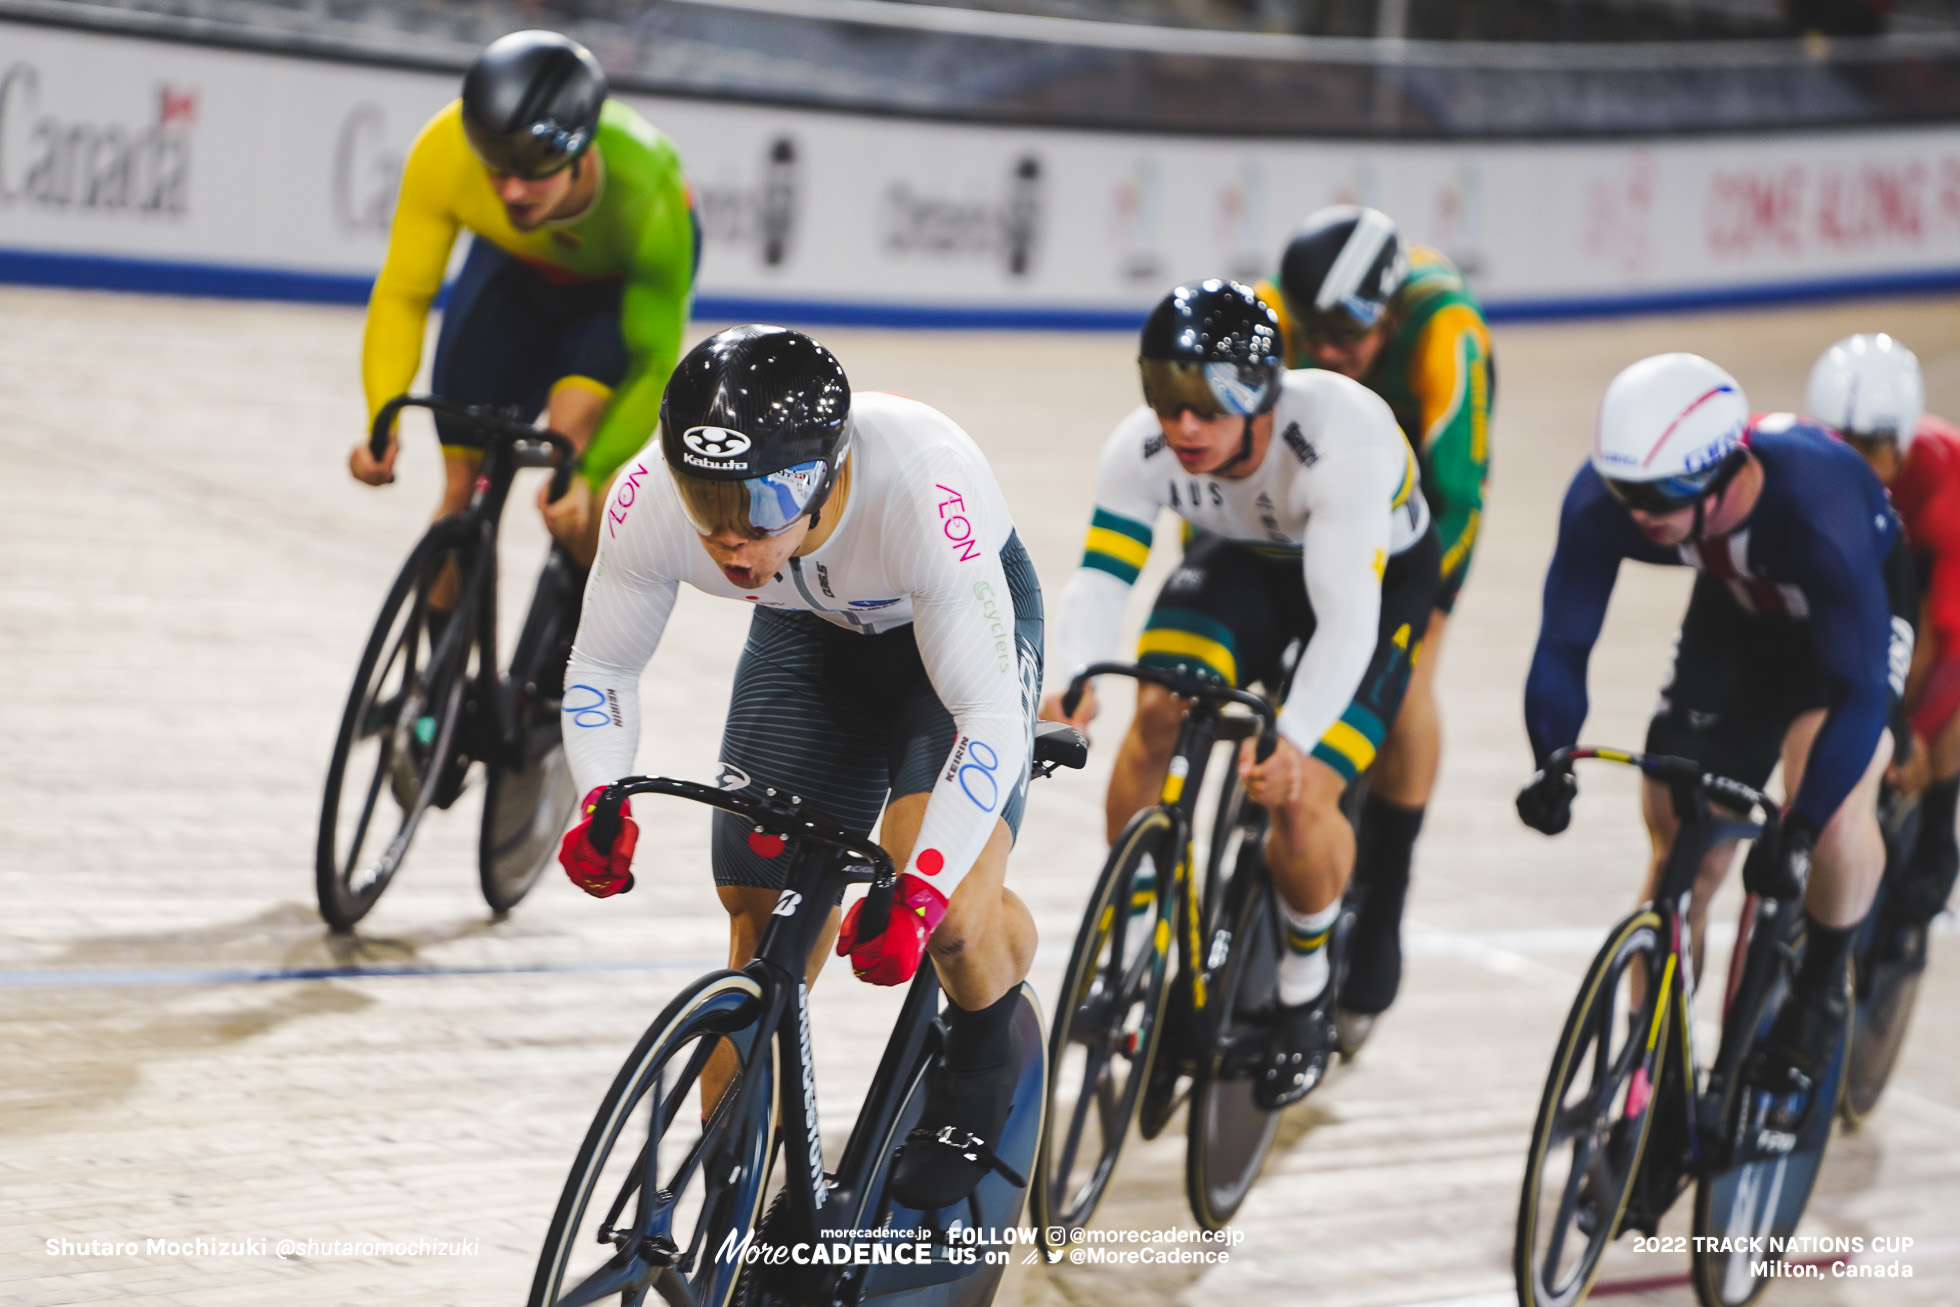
xmin=476 ymin=547 xmax=580 ymax=913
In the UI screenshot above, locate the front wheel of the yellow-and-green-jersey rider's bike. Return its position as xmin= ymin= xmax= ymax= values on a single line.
xmin=314 ymin=521 xmax=474 ymax=931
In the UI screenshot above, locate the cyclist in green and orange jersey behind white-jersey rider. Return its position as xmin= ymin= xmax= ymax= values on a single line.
xmin=1258 ymin=204 xmax=1495 ymax=1052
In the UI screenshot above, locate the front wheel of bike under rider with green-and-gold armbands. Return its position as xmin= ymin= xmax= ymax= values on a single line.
xmin=1033 ymin=807 xmax=1178 ymax=1238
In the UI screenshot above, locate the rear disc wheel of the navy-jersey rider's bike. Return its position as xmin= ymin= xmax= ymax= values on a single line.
xmin=1690 ymin=956 xmax=1850 ymax=1307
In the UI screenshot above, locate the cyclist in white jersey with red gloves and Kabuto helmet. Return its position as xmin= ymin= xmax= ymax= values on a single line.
xmin=561 ymin=327 xmax=1041 ymax=1209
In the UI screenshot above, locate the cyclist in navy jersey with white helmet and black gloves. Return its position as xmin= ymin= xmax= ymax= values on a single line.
xmin=1517 ymin=355 xmax=1915 ymax=1146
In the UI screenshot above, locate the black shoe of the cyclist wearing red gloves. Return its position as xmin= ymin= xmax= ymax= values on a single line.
xmin=888 ymin=1042 xmax=1027 ymax=1211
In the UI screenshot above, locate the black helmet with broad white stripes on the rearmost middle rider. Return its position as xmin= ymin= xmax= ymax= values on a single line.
xmin=1280 ymin=204 xmax=1409 ymax=341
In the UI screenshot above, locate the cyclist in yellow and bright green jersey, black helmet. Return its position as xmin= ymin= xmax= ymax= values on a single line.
xmin=349 ymin=31 xmax=698 ymax=568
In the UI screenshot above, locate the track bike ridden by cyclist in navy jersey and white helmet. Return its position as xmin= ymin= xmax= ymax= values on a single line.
xmin=1513 ymin=749 xmax=1848 ymax=1307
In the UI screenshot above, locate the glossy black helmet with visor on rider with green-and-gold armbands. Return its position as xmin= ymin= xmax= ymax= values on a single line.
xmin=1137 ymin=280 xmax=1282 ymax=417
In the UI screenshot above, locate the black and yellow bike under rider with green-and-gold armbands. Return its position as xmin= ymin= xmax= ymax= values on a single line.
xmin=1035 ymin=662 xmax=1317 ymax=1246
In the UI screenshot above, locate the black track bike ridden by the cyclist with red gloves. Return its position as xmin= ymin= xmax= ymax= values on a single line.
xmin=529 ymin=723 xmax=1088 ymax=1307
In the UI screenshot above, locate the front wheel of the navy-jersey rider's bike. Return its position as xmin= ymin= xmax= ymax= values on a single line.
xmin=1511 ymin=909 xmax=1678 ymax=1307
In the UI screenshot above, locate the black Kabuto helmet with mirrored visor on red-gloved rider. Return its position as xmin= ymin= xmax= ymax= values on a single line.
xmin=661 ymin=325 xmax=851 ymax=539
